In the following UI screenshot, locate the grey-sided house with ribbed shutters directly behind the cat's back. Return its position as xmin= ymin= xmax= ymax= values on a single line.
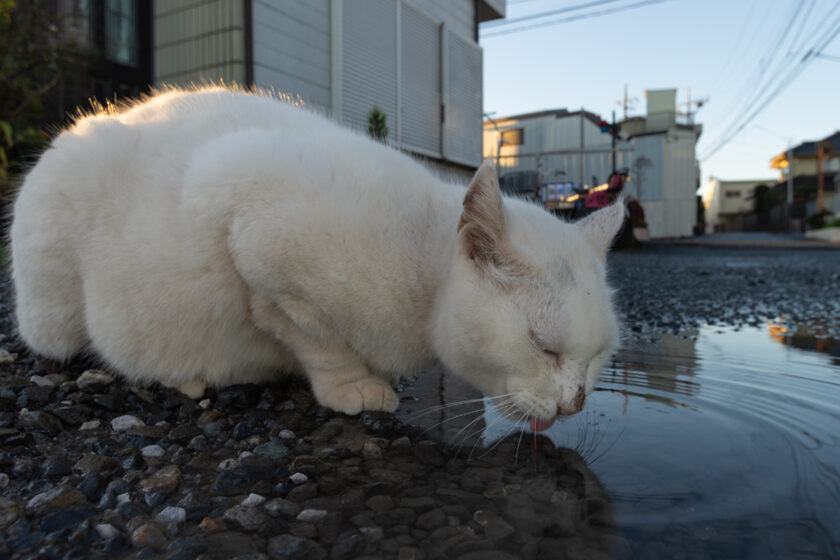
xmin=153 ymin=0 xmax=505 ymax=178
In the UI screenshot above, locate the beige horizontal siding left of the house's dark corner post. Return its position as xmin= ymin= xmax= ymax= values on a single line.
xmin=153 ymin=0 xmax=245 ymax=86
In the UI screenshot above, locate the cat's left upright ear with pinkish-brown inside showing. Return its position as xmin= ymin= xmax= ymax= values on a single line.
xmin=458 ymin=159 xmax=528 ymax=275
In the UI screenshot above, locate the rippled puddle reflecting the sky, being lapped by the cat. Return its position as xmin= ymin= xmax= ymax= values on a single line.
xmin=398 ymin=323 xmax=840 ymax=559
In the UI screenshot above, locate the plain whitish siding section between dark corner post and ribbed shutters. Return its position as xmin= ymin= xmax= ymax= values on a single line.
xmin=252 ymin=0 xmax=330 ymax=108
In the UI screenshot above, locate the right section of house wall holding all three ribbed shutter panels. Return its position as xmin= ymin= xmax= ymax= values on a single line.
xmin=332 ymin=0 xmax=482 ymax=167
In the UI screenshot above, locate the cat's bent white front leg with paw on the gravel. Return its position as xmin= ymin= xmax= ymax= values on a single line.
xmin=251 ymin=296 xmax=398 ymax=415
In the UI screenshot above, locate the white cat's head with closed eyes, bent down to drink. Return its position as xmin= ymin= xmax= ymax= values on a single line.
xmin=434 ymin=163 xmax=624 ymax=420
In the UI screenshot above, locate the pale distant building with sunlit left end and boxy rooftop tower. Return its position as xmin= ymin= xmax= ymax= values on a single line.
xmin=484 ymin=89 xmax=702 ymax=238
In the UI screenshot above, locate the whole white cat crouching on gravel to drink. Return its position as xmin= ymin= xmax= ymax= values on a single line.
xmin=12 ymin=88 xmax=624 ymax=419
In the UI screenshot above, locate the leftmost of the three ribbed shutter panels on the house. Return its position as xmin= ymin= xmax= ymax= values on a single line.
xmin=341 ymin=0 xmax=398 ymax=135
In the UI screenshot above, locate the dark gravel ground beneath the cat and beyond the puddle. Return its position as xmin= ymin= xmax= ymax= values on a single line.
xmin=0 ymin=244 xmax=840 ymax=560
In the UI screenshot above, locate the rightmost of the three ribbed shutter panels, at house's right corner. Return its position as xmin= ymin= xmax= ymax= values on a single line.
xmin=443 ymin=30 xmax=482 ymax=166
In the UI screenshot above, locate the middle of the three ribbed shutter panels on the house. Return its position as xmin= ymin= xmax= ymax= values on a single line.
xmin=399 ymin=4 xmax=441 ymax=157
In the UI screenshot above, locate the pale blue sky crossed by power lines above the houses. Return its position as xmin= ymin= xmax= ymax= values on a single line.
xmin=480 ymin=0 xmax=840 ymax=188
